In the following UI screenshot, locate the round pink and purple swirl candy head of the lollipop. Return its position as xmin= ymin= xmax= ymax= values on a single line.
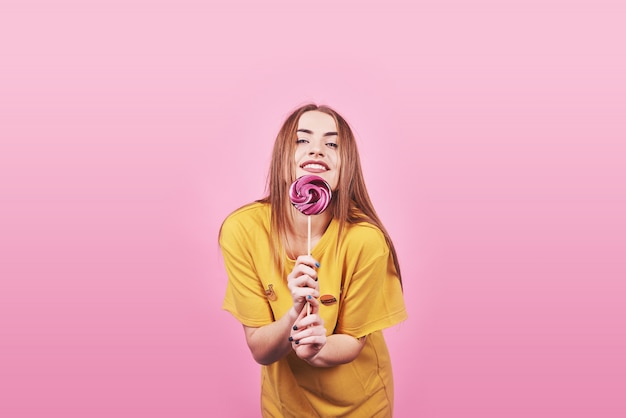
xmin=289 ymin=174 xmax=333 ymax=215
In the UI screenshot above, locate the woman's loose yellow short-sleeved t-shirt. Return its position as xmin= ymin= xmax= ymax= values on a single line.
xmin=220 ymin=203 xmax=407 ymax=417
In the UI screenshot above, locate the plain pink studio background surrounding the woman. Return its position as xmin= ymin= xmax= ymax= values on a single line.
xmin=0 ymin=0 xmax=626 ymax=418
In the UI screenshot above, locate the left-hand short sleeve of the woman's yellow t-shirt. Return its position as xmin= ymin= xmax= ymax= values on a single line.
xmin=219 ymin=212 xmax=274 ymax=327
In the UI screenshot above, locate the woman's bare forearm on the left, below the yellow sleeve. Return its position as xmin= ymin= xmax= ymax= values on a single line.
xmin=243 ymin=307 xmax=298 ymax=365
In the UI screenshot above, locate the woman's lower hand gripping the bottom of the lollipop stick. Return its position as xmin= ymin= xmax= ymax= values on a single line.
xmin=289 ymin=297 xmax=326 ymax=361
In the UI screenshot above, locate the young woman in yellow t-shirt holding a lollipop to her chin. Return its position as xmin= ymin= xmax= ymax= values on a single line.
xmin=219 ymin=104 xmax=407 ymax=417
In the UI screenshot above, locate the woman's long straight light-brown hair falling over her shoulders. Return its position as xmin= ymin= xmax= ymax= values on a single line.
xmin=259 ymin=103 xmax=402 ymax=285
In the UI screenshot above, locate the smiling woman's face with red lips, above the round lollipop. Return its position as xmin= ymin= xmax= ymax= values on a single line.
xmin=295 ymin=110 xmax=341 ymax=190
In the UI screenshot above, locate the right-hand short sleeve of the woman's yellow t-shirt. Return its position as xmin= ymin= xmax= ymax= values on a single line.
xmin=335 ymin=228 xmax=407 ymax=337
